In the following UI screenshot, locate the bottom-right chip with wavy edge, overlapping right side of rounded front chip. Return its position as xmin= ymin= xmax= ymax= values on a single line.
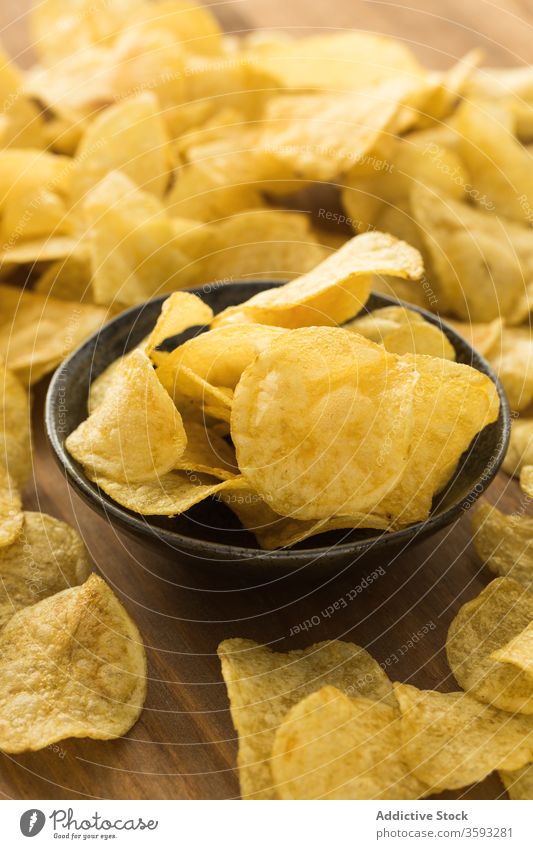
xmin=394 ymin=684 xmax=533 ymax=793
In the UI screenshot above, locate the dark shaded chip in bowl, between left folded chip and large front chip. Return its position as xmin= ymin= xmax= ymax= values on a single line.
xmin=175 ymin=421 xmax=239 ymax=480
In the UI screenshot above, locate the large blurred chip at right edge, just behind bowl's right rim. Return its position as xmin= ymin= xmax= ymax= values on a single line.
xmin=411 ymin=185 xmax=533 ymax=323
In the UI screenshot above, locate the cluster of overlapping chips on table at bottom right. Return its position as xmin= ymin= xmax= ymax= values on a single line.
xmin=218 ymin=578 xmax=533 ymax=799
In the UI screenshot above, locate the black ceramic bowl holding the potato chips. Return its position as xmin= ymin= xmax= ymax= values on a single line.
xmin=46 ymin=281 xmax=510 ymax=578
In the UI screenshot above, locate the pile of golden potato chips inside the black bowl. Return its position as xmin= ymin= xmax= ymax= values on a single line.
xmin=66 ymin=231 xmax=500 ymax=548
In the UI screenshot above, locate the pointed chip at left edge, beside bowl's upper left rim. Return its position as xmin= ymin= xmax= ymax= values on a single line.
xmin=0 ymin=284 xmax=108 ymax=382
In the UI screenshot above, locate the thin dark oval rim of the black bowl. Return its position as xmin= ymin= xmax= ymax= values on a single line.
xmin=44 ymin=280 xmax=511 ymax=567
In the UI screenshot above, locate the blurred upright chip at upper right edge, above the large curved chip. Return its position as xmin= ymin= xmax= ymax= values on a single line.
xmin=454 ymin=102 xmax=533 ymax=222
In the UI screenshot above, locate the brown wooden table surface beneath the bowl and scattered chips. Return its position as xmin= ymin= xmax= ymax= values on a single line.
xmin=0 ymin=0 xmax=533 ymax=799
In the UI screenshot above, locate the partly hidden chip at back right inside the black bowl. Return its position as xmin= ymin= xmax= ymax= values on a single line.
xmin=344 ymin=307 xmax=455 ymax=360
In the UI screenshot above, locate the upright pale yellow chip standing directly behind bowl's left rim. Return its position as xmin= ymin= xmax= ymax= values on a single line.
xmin=84 ymin=171 xmax=191 ymax=306
